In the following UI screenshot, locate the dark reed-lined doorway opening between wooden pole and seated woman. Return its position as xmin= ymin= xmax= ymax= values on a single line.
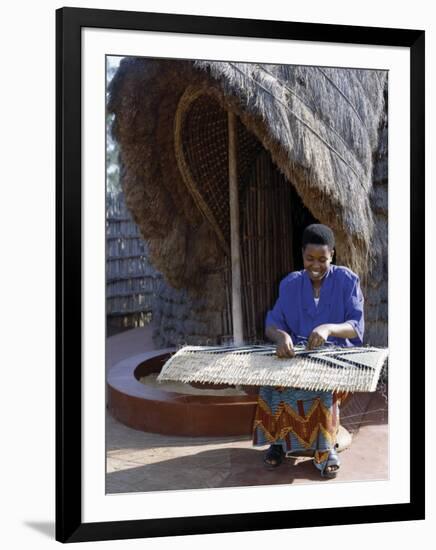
xmin=240 ymin=149 xmax=316 ymax=343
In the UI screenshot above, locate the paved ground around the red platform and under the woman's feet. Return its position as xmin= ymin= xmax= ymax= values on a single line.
xmin=106 ymin=329 xmax=389 ymax=493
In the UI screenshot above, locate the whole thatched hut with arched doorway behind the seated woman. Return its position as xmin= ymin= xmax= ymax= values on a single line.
xmin=109 ymin=58 xmax=387 ymax=345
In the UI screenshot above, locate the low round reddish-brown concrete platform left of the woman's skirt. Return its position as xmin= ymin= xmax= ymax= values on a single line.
xmin=107 ymin=349 xmax=257 ymax=437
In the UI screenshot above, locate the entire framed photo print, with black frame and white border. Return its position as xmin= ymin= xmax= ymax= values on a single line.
xmin=56 ymin=8 xmax=425 ymax=542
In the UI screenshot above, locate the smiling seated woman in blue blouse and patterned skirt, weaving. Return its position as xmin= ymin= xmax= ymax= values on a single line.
xmin=253 ymin=224 xmax=364 ymax=478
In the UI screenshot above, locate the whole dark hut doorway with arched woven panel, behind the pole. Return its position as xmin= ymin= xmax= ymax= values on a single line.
xmin=175 ymin=92 xmax=317 ymax=343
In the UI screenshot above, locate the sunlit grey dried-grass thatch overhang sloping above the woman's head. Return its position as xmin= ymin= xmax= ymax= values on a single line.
xmin=195 ymin=62 xmax=385 ymax=276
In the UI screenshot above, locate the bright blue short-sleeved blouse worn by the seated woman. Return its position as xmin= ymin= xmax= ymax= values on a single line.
xmin=265 ymin=265 xmax=365 ymax=347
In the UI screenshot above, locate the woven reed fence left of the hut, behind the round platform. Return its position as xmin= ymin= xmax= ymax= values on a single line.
xmin=106 ymin=193 xmax=163 ymax=327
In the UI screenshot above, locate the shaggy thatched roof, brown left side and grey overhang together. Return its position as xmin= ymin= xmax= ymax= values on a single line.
xmin=109 ymin=58 xmax=386 ymax=287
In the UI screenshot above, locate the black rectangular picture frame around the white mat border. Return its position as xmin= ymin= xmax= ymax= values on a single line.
xmin=56 ymin=8 xmax=425 ymax=542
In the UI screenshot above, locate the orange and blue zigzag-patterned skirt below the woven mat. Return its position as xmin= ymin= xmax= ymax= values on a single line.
xmin=253 ymin=386 xmax=345 ymax=461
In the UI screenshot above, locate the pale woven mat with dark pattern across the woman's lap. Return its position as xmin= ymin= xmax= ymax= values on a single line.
xmin=158 ymin=346 xmax=388 ymax=392
